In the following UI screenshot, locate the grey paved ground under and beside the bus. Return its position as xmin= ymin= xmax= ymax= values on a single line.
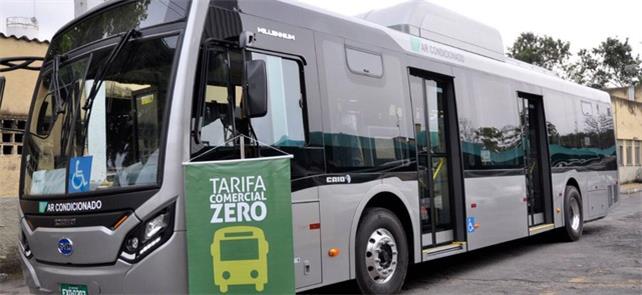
xmin=0 ymin=192 xmax=642 ymax=295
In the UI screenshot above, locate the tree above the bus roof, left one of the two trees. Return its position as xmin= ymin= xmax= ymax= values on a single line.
xmin=508 ymin=32 xmax=571 ymax=76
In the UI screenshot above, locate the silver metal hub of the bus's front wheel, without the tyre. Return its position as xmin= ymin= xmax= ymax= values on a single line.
xmin=365 ymin=228 xmax=398 ymax=284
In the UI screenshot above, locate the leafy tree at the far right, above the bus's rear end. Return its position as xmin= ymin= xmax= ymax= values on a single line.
xmin=567 ymin=37 xmax=642 ymax=89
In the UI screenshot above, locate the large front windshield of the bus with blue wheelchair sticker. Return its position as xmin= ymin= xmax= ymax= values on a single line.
xmin=22 ymin=1 xmax=185 ymax=196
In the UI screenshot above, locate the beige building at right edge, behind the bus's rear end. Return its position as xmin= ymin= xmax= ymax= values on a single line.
xmin=607 ymin=84 xmax=642 ymax=183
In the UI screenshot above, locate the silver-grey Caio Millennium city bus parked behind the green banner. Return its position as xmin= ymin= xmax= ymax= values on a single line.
xmin=13 ymin=0 xmax=618 ymax=293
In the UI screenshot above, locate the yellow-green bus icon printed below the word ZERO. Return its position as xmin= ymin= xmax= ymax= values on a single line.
xmin=210 ymin=226 xmax=269 ymax=293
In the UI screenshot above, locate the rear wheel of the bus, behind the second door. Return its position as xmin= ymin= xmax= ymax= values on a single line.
xmin=560 ymin=185 xmax=584 ymax=242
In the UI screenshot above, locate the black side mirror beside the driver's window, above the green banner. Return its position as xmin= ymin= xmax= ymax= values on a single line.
xmin=245 ymin=60 xmax=268 ymax=118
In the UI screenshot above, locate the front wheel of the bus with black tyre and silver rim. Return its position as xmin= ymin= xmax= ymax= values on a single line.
xmin=355 ymin=208 xmax=408 ymax=294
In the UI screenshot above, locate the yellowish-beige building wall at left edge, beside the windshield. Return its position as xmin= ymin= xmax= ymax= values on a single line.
xmin=0 ymin=33 xmax=49 ymax=197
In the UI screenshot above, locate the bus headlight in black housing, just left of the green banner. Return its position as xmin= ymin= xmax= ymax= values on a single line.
xmin=120 ymin=204 xmax=175 ymax=263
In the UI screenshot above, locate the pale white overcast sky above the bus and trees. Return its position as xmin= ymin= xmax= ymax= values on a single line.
xmin=0 ymin=0 xmax=642 ymax=56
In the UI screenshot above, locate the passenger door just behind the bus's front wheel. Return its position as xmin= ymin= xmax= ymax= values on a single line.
xmin=409 ymin=70 xmax=463 ymax=252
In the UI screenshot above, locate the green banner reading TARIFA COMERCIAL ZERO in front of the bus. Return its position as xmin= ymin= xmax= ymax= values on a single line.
xmin=184 ymin=156 xmax=294 ymax=294
